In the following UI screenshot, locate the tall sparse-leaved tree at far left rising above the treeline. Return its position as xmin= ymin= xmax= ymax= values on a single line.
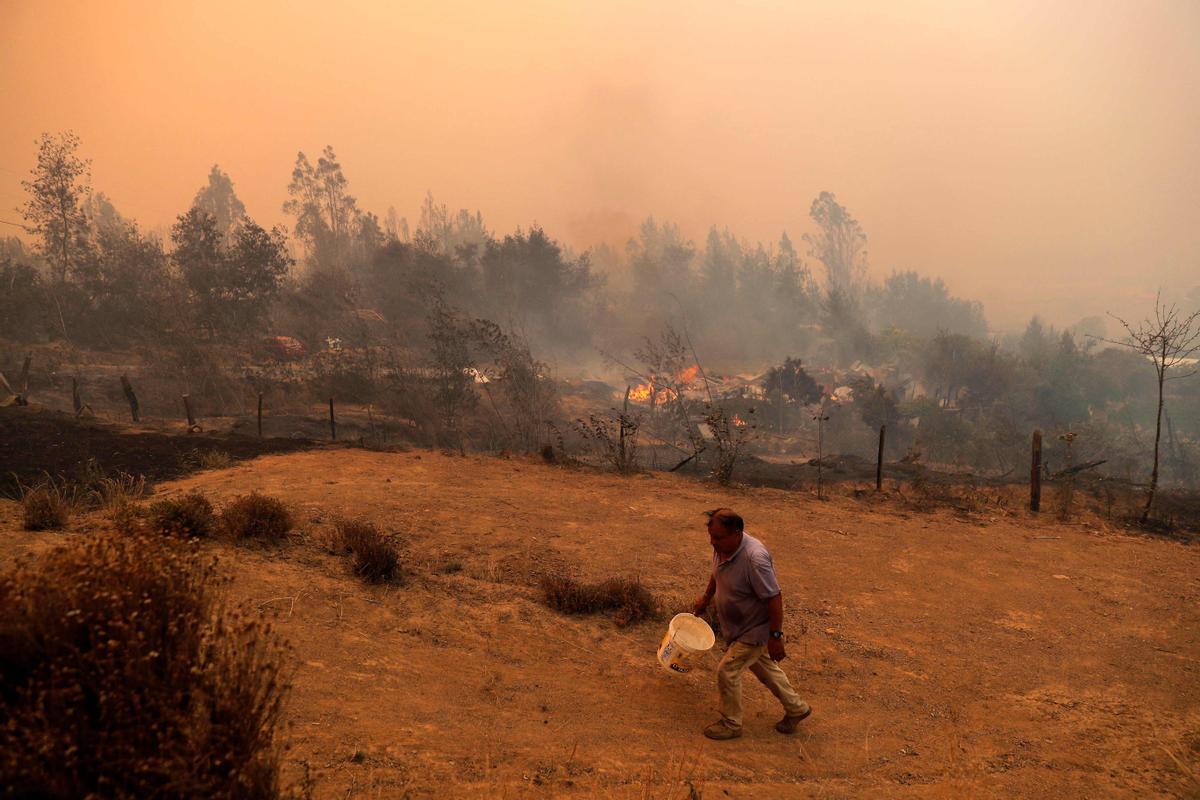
xmin=20 ymin=131 xmax=91 ymax=284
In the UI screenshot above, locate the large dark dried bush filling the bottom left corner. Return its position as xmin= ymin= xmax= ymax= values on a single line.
xmin=0 ymin=535 xmax=286 ymax=800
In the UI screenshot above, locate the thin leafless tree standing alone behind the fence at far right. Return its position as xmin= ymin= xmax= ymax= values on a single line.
xmin=1100 ymin=291 xmax=1200 ymax=523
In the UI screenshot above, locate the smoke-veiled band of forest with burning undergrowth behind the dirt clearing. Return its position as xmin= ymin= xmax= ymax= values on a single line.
xmin=0 ymin=133 xmax=1200 ymax=510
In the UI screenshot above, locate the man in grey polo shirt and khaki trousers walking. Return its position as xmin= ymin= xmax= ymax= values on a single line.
xmin=695 ymin=509 xmax=812 ymax=739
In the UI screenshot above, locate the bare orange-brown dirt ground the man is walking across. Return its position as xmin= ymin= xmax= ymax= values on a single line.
xmin=0 ymin=450 xmax=1200 ymax=799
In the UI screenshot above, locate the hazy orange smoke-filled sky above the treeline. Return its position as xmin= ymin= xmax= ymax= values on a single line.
xmin=0 ymin=0 xmax=1200 ymax=329
